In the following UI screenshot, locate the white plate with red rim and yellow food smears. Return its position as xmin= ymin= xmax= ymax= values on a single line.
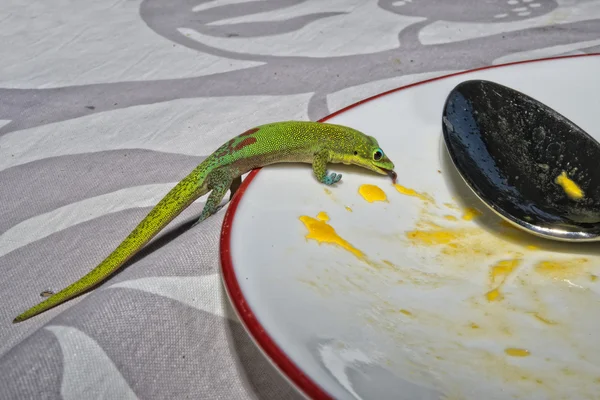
xmin=221 ymin=56 xmax=600 ymax=400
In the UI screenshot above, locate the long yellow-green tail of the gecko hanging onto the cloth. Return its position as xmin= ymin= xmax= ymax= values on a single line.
xmin=13 ymin=163 xmax=208 ymax=323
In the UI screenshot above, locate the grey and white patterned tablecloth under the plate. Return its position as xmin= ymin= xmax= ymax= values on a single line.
xmin=0 ymin=0 xmax=600 ymax=399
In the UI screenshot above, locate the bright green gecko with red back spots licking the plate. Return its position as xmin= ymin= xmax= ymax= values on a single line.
xmin=13 ymin=121 xmax=396 ymax=323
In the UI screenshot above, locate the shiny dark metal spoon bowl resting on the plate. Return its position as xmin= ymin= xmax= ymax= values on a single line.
xmin=442 ymin=80 xmax=600 ymax=241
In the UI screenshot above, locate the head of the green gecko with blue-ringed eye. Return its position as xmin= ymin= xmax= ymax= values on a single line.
xmin=342 ymin=135 xmax=396 ymax=183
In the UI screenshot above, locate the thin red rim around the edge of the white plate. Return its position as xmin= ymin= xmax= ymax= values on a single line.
xmin=220 ymin=53 xmax=600 ymax=400
